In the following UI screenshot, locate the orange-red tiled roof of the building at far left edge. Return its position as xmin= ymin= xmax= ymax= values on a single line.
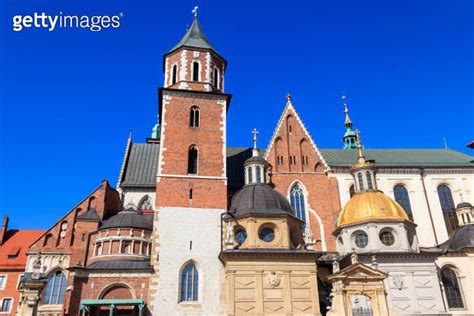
xmin=0 ymin=229 xmax=44 ymax=269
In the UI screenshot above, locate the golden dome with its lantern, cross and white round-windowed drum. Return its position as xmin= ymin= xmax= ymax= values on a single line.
xmin=333 ymin=130 xmax=416 ymax=254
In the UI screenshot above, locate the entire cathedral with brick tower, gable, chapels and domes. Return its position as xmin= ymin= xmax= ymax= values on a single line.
xmin=0 ymin=10 xmax=474 ymax=316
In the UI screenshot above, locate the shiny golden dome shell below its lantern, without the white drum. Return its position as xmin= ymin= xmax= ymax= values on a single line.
xmin=337 ymin=191 xmax=410 ymax=228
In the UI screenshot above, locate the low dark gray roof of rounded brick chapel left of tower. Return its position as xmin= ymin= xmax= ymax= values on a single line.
xmin=99 ymin=208 xmax=153 ymax=230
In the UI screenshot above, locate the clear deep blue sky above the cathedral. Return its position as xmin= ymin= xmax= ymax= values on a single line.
xmin=0 ymin=0 xmax=474 ymax=229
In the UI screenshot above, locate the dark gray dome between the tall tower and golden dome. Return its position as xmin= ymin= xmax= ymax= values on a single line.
xmin=229 ymin=183 xmax=293 ymax=217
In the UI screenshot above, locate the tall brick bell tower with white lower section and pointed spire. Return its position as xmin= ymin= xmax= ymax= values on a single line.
xmin=149 ymin=9 xmax=231 ymax=315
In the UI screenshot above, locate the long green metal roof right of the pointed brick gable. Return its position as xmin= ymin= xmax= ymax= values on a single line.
xmin=320 ymin=149 xmax=474 ymax=168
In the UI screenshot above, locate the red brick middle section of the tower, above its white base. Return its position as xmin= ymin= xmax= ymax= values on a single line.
xmin=156 ymin=91 xmax=227 ymax=208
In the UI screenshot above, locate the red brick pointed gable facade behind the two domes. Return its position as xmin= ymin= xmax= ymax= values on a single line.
xmin=266 ymin=102 xmax=340 ymax=251
